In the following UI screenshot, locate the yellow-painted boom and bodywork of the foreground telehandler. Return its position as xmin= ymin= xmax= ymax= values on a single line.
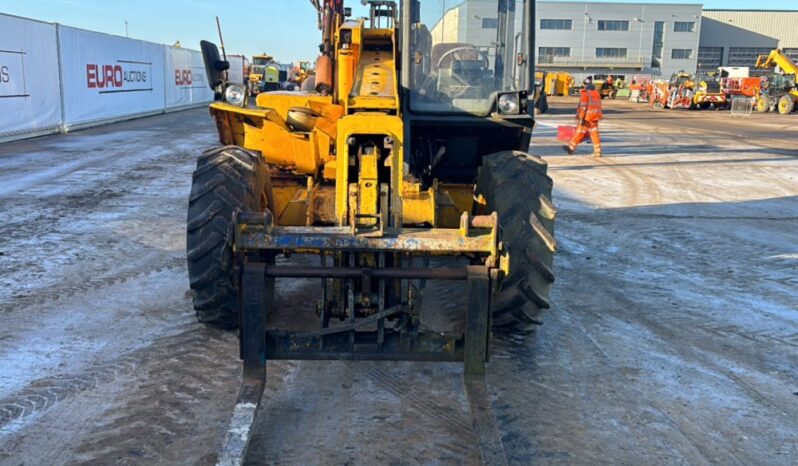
xmin=210 ymin=13 xmax=498 ymax=261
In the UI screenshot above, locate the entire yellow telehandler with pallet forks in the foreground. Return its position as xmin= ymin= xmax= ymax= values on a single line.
xmin=194 ymin=0 xmax=556 ymax=464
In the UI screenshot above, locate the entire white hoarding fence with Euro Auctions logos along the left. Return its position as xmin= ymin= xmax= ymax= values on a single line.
xmin=0 ymin=13 xmax=245 ymax=142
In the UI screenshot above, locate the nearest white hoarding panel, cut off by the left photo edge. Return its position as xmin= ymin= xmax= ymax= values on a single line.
xmin=0 ymin=14 xmax=61 ymax=141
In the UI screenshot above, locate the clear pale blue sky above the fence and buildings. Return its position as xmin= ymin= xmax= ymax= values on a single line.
xmin=0 ymin=0 xmax=798 ymax=62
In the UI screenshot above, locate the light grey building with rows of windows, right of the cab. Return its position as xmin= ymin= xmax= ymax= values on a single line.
xmin=535 ymin=2 xmax=701 ymax=80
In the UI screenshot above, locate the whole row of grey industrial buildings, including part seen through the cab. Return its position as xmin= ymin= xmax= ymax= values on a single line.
xmin=432 ymin=0 xmax=798 ymax=79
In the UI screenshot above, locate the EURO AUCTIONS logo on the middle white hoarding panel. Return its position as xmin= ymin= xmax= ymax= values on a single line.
xmin=86 ymin=60 xmax=153 ymax=94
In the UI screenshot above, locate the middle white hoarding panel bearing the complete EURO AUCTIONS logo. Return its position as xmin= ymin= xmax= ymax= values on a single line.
xmin=58 ymin=26 xmax=164 ymax=128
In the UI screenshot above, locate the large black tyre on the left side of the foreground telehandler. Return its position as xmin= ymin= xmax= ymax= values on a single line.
xmin=186 ymin=146 xmax=269 ymax=329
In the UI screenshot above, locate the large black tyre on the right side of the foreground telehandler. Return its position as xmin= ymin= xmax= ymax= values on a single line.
xmin=477 ymin=151 xmax=557 ymax=332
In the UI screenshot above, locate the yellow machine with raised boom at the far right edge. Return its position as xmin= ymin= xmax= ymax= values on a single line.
xmin=755 ymin=49 xmax=798 ymax=115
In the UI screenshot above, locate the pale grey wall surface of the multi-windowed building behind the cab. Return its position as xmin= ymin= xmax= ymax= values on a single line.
xmin=433 ymin=0 xmax=702 ymax=78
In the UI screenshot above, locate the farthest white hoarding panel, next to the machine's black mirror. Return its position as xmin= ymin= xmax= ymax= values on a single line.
xmin=164 ymin=46 xmax=213 ymax=110
